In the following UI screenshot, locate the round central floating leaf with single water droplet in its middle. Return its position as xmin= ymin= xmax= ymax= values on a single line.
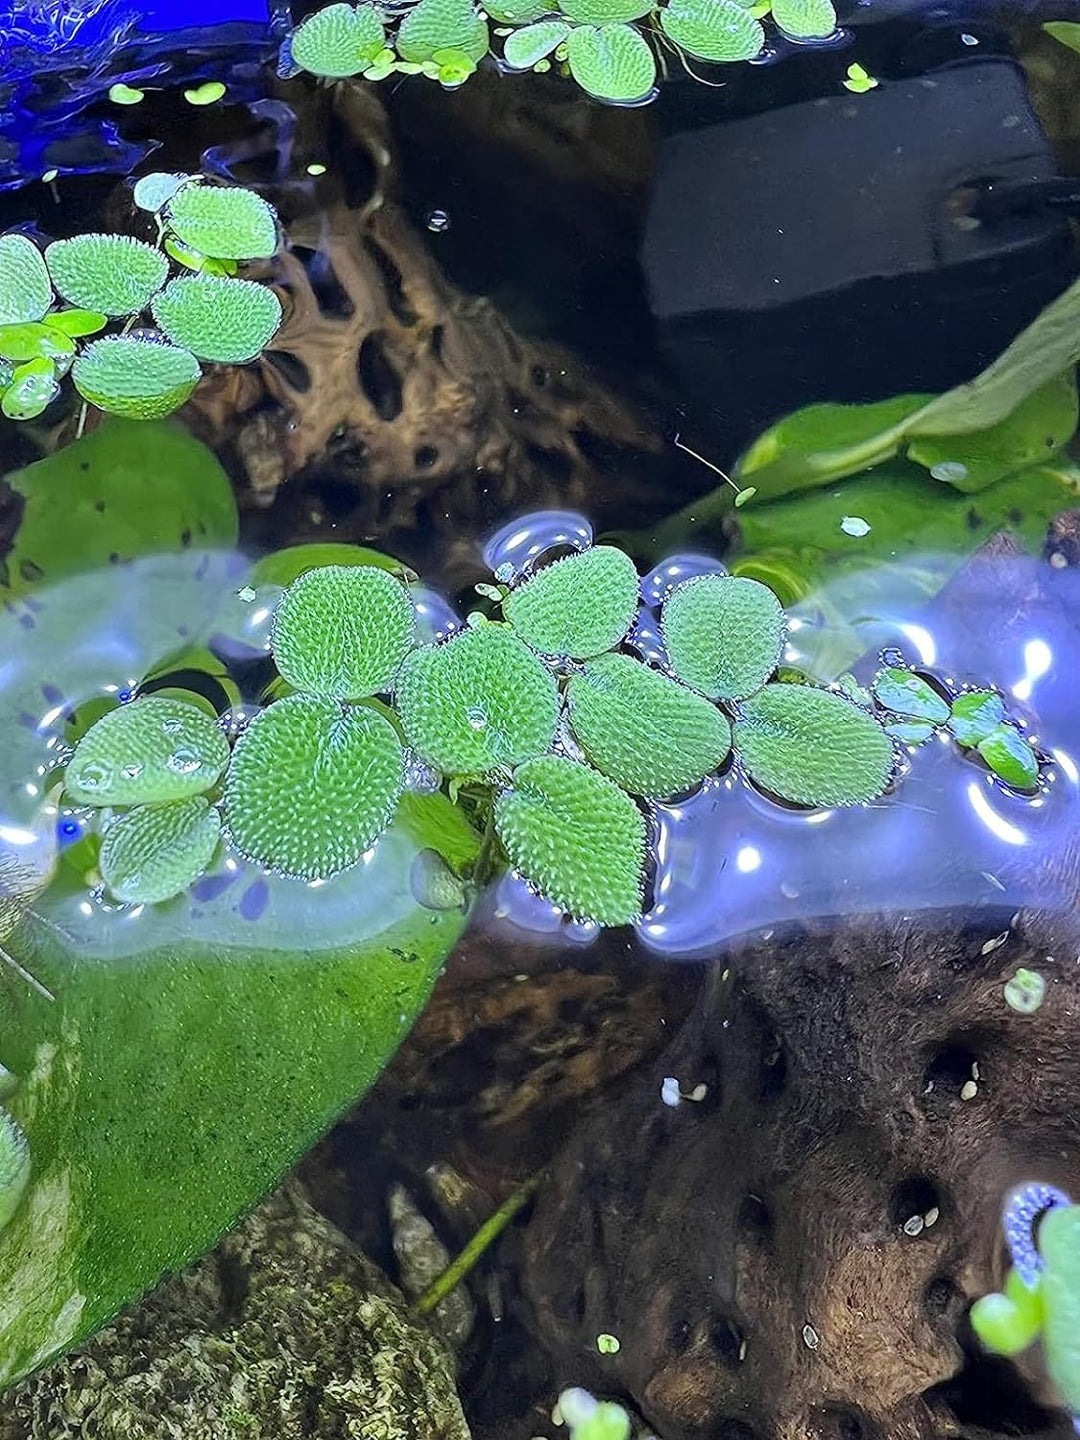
xmin=396 ymin=624 xmax=559 ymax=775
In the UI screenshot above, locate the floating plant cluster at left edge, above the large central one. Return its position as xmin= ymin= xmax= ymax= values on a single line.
xmin=0 ymin=174 xmax=281 ymax=420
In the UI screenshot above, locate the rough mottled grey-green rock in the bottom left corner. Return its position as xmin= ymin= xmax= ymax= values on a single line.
xmin=0 ymin=1184 xmax=469 ymax=1440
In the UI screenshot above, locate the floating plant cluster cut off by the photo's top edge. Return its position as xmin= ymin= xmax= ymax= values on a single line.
xmin=282 ymin=0 xmax=837 ymax=105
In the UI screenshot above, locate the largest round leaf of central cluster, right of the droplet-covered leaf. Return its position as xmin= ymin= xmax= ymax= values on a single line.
xmin=225 ymin=696 xmax=405 ymax=880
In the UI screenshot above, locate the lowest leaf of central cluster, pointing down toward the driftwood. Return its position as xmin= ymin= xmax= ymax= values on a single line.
xmin=495 ymin=755 xmax=645 ymax=924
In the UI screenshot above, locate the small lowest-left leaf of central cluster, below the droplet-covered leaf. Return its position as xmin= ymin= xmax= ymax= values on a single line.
xmin=98 ymin=795 xmax=222 ymax=904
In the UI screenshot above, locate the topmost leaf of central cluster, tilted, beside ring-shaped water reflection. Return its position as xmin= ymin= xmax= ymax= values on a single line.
xmin=503 ymin=544 xmax=638 ymax=660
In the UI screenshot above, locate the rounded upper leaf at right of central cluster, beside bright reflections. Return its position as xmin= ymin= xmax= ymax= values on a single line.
xmin=661 ymin=575 xmax=785 ymax=700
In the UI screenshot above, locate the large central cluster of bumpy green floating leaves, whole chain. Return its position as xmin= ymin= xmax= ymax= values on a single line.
xmin=50 ymin=544 xmax=1038 ymax=924
